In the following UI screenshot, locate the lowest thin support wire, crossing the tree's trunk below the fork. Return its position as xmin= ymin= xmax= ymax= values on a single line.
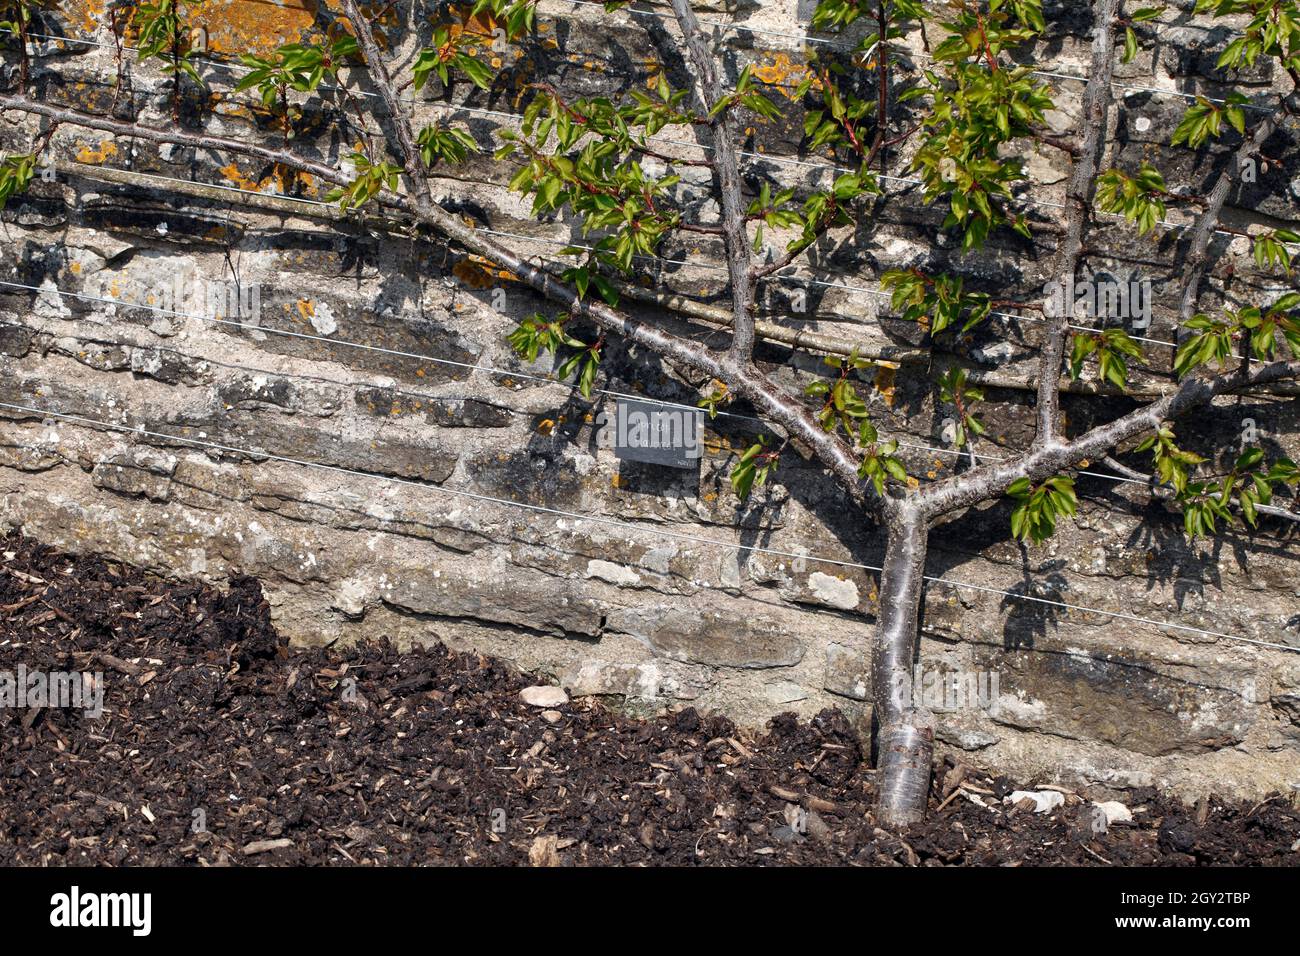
xmin=0 ymin=402 xmax=1300 ymax=653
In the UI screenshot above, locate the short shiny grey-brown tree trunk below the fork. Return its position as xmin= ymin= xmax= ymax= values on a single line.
xmin=871 ymin=505 xmax=935 ymax=827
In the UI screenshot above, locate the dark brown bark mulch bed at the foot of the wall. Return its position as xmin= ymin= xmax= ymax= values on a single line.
xmin=0 ymin=536 xmax=1300 ymax=866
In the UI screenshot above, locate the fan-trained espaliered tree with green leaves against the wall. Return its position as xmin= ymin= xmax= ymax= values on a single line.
xmin=0 ymin=0 xmax=1300 ymax=825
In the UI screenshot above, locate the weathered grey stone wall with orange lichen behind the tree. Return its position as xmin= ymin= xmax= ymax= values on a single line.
xmin=0 ymin=0 xmax=1300 ymax=795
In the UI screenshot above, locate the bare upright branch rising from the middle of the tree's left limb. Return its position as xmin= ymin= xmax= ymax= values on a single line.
xmin=672 ymin=0 xmax=755 ymax=364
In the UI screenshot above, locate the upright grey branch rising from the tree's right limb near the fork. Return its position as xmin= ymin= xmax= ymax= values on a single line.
xmin=1034 ymin=0 xmax=1119 ymax=446
